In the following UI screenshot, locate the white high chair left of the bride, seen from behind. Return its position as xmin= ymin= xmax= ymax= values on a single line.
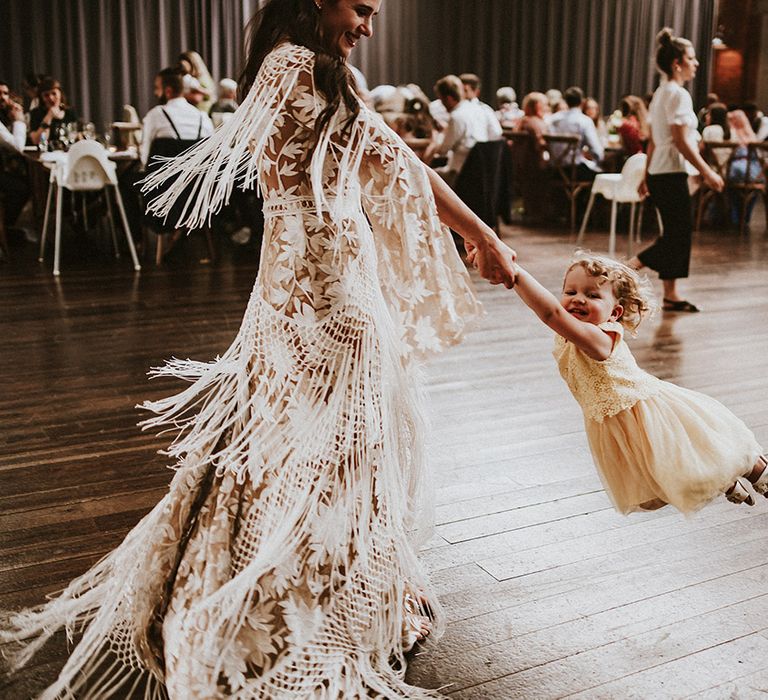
xmin=39 ymin=140 xmax=141 ymax=276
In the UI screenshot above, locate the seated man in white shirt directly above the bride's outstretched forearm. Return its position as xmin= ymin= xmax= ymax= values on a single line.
xmin=424 ymin=75 xmax=488 ymax=186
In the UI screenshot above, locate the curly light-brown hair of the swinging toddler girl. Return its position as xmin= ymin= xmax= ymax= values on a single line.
xmin=565 ymin=251 xmax=656 ymax=332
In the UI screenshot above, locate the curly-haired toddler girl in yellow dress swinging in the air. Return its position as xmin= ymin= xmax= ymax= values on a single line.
xmin=508 ymin=254 xmax=768 ymax=513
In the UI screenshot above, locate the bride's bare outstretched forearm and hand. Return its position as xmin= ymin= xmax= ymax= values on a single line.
xmin=425 ymin=166 xmax=517 ymax=289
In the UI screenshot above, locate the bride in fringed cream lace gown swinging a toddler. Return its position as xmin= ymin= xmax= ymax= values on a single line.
xmin=0 ymin=0 xmax=515 ymax=700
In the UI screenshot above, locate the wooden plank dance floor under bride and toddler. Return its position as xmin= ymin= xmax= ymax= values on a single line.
xmin=0 ymin=211 xmax=768 ymax=700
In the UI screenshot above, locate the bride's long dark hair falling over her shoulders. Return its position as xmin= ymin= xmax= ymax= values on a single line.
xmin=238 ymin=0 xmax=360 ymax=136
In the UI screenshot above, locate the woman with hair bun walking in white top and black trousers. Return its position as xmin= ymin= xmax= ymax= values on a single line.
xmin=629 ymin=27 xmax=723 ymax=311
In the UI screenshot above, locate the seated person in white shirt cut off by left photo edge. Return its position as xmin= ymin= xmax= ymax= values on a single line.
xmin=0 ymin=80 xmax=30 ymax=241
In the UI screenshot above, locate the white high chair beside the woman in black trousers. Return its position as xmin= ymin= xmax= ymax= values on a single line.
xmin=577 ymin=153 xmax=648 ymax=257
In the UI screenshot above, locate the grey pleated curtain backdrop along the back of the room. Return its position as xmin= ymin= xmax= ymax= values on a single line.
xmin=0 ymin=0 xmax=716 ymax=126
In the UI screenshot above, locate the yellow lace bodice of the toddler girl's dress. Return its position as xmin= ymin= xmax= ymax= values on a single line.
xmin=552 ymin=321 xmax=662 ymax=423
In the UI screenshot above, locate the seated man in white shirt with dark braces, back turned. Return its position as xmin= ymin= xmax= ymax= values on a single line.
xmin=141 ymin=68 xmax=213 ymax=166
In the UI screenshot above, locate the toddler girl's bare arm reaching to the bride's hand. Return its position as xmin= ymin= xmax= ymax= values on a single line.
xmin=515 ymin=265 xmax=613 ymax=360
